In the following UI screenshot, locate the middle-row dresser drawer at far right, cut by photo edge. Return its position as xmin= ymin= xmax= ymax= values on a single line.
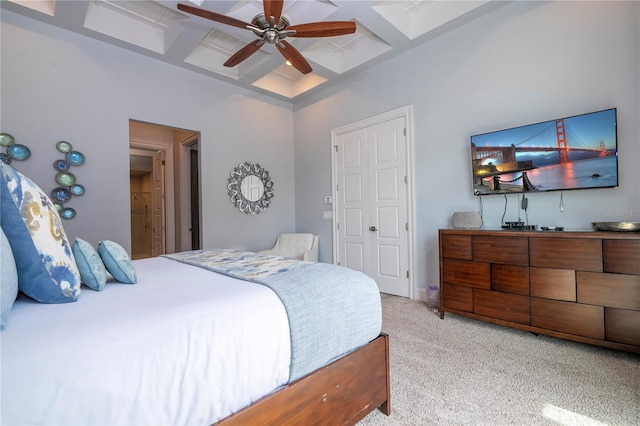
xmin=577 ymin=271 xmax=640 ymax=311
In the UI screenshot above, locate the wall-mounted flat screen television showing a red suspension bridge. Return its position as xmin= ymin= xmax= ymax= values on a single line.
xmin=471 ymin=108 xmax=618 ymax=195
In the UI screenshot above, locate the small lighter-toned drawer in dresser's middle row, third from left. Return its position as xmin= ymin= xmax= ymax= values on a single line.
xmin=529 ymin=268 xmax=576 ymax=302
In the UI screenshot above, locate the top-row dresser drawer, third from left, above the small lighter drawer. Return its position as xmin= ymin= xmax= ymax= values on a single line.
xmin=529 ymin=238 xmax=602 ymax=272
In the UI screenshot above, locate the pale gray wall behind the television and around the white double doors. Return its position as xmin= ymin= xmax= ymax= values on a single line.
xmin=294 ymin=2 xmax=640 ymax=296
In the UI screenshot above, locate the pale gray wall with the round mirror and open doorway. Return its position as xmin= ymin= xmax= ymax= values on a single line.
xmin=0 ymin=10 xmax=295 ymax=253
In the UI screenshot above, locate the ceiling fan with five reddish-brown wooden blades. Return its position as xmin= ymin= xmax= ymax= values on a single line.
xmin=178 ymin=0 xmax=356 ymax=74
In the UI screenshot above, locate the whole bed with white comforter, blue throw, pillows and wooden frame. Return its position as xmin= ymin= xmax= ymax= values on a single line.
xmin=0 ymin=164 xmax=390 ymax=425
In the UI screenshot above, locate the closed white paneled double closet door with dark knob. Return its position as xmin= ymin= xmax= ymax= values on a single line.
xmin=334 ymin=117 xmax=410 ymax=297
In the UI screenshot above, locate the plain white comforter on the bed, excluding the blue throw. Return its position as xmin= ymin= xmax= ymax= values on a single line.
xmin=0 ymin=258 xmax=290 ymax=425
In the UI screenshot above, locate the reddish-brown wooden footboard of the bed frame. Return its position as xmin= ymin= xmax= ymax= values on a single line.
xmin=216 ymin=333 xmax=391 ymax=426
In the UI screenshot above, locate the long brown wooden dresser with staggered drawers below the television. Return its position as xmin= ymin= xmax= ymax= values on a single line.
xmin=439 ymin=229 xmax=640 ymax=353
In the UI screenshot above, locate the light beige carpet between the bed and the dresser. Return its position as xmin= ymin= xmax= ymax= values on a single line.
xmin=359 ymin=294 xmax=640 ymax=426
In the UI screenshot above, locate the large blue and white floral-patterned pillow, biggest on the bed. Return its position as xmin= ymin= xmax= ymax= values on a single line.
xmin=0 ymin=161 xmax=80 ymax=303
